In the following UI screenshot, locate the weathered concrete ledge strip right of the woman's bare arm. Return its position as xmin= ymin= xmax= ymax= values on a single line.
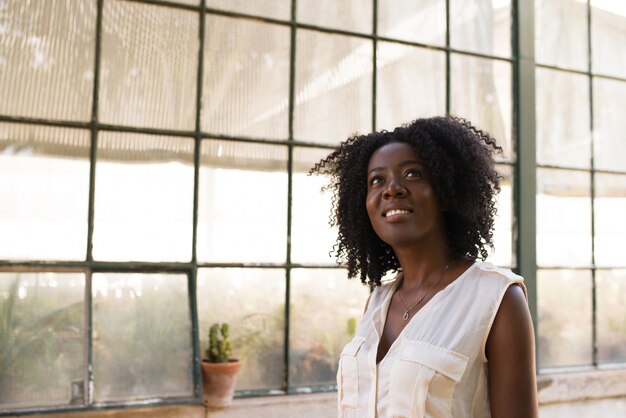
xmin=537 ymin=369 xmax=626 ymax=405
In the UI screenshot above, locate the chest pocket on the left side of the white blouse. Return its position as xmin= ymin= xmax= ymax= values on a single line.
xmin=337 ymin=336 xmax=367 ymax=409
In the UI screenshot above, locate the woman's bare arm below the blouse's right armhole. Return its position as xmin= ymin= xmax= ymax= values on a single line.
xmin=487 ymin=285 xmax=539 ymax=418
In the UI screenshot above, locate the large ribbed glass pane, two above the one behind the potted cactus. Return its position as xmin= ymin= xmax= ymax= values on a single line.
xmin=201 ymin=15 xmax=291 ymax=139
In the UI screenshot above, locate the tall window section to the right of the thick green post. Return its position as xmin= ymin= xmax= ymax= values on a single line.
xmin=535 ymin=0 xmax=626 ymax=370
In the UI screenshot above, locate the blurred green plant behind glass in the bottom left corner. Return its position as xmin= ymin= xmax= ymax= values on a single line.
xmin=0 ymin=273 xmax=84 ymax=402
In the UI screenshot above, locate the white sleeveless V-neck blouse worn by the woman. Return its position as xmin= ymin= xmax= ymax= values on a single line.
xmin=337 ymin=261 xmax=526 ymax=418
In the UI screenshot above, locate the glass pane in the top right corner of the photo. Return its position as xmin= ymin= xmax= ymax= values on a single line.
xmin=591 ymin=0 xmax=626 ymax=77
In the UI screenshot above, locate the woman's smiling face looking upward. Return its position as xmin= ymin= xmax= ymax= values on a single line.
xmin=365 ymin=142 xmax=446 ymax=249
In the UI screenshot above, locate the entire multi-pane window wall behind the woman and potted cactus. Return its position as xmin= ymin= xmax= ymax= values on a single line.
xmin=0 ymin=0 xmax=626 ymax=414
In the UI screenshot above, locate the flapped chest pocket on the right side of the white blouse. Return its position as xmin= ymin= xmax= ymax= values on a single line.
xmin=389 ymin=340 xmax=468 ymax=418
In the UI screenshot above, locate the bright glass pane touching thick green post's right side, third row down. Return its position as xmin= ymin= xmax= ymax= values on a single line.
xmin=537 ymin=169 xmax=591 ymax=266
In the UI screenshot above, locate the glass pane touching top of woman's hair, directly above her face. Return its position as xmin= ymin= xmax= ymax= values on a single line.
xmin=376 ymin=42 xmax=446 ymax=130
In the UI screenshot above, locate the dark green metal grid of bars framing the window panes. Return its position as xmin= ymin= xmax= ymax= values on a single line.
xmin=0 ymin=0 xmax=626 ymax=416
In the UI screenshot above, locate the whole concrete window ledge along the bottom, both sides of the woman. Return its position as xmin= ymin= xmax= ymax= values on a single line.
xmin=9 ymin=368 xmax=626 ymax=418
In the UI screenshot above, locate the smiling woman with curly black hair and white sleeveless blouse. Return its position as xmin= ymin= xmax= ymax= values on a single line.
xmin=312 ymin=116 xmax=538 ymax=418
